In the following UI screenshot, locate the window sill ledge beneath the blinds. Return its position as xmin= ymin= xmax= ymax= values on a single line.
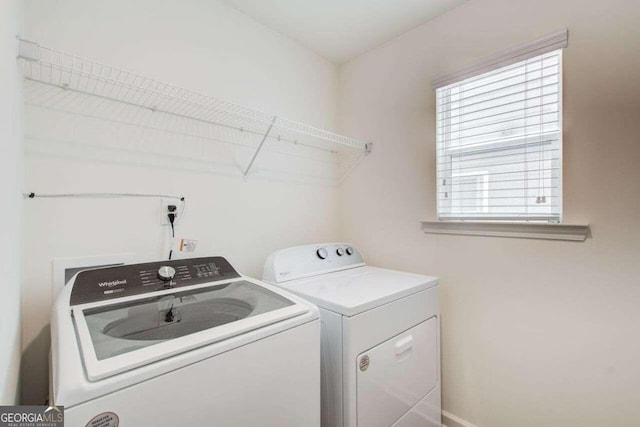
xmin=422 ymin=221 xmax=591 ymax=242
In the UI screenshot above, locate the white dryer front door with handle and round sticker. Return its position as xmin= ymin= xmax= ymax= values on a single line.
xmin=356 ymin=317 xmax=438 ymax=427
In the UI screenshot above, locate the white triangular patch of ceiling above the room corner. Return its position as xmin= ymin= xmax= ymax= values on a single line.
xmin=222 ymin=0 xmax=466 ymax=64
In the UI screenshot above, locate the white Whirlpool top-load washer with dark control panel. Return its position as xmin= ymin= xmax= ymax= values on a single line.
xmin=51 ymin=257 xmax=320 ymax=427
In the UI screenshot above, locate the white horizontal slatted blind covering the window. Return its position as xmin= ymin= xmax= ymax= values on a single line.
xmin=436 ymin=49 xmax=562 ymax=222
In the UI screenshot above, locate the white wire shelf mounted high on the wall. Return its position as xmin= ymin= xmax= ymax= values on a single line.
xmin=18 ymin=39 xmax=372 ymax=181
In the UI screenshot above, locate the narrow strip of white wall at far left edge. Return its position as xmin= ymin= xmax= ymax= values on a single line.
xmin=0 ymin=0 xmax=23 ymax=405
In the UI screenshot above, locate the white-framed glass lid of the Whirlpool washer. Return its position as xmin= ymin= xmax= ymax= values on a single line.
xmin=72 ymin=280 xmax=309 ymax=381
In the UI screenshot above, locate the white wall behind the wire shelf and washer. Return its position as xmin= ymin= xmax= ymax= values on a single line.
xmin=21 ymin=0 xmax=339 ymax=403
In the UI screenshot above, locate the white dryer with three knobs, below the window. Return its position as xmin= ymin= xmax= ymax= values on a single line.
xmin=263 ymin=243 xmax=441 ymax=427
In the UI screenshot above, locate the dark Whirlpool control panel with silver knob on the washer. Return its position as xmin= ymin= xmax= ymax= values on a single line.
xmin=70 ymin=257 xmax=240 ymax=305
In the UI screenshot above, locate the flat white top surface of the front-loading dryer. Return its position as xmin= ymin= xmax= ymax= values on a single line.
xmin=278 ymin=266 xmax=438 ymax=316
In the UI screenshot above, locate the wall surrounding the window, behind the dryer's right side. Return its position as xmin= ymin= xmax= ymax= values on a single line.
xmin=339 ymin=0 xmax=640 ymax=427
